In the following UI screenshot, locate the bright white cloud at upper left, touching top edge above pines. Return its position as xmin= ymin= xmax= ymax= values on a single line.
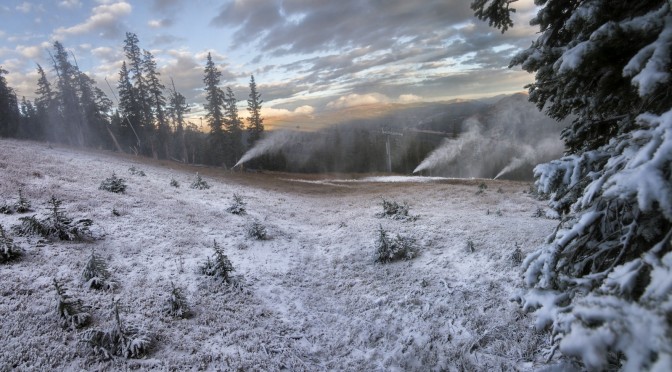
xmin=55 ymin=2 xmax=132 ymax=40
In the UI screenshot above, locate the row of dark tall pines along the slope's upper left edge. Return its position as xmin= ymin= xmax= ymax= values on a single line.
xmin=0 ymin=32 xmax=264 ymax=167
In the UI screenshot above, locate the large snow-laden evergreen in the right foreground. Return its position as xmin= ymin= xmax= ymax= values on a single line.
xmin=472 ymin=0 xmax=672 ymax=371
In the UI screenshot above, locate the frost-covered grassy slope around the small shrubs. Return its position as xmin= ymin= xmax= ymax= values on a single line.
xmin=0 ymin=140 xmax=557 ymax=371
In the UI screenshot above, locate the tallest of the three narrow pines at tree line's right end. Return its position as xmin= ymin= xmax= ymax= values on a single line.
xmin=203 ymin=53 xmax=226 ymax=165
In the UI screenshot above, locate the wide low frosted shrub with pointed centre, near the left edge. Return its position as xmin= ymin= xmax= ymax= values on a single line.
xmin=14 ymin=196 xmax=93 ymax=241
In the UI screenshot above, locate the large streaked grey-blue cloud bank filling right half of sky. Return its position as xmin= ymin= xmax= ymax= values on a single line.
xmin=210 ymin=0 xmax=535 ymax=112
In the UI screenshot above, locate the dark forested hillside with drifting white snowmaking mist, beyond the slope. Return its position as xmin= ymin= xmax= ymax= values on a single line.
xmin=239 ymin=94 xmax=563 ymax=180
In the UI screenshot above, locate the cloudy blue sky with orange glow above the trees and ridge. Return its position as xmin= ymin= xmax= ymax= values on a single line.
xmin=0 ymin=0 xmax=536 ymax=127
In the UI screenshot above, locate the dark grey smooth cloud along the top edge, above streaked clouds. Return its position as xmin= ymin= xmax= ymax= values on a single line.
xmin=211 ymin=0 xmax=473 ymax=54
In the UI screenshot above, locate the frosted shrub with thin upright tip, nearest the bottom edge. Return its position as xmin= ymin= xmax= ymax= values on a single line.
xmin=79 ymin=301 xmax=152 ymax=360
